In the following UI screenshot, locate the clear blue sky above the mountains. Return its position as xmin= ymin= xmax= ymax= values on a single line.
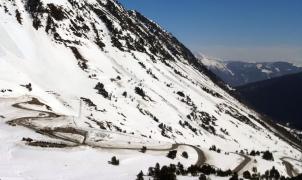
xmin=119 ymin=0 xmax=302 ymax=64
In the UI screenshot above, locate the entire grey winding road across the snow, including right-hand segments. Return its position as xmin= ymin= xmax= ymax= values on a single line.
xmin=7 ymin=98 xmax=298 ymax=177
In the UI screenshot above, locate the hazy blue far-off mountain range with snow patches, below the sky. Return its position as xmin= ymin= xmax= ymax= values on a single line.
xmin=199 ymin=56 xmax=302 ymax=87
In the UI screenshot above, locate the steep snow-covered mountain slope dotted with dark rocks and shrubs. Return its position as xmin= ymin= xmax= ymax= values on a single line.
xmin=0 ymin=0 xmax=301 ymax=179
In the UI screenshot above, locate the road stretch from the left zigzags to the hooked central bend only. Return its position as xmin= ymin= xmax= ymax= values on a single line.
xmin=7 ymin=97 xmax=206 ymax=166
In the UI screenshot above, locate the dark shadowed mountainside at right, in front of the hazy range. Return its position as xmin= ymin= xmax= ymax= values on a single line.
xmin=237 ymin=73 xmax=302 ymax=130
